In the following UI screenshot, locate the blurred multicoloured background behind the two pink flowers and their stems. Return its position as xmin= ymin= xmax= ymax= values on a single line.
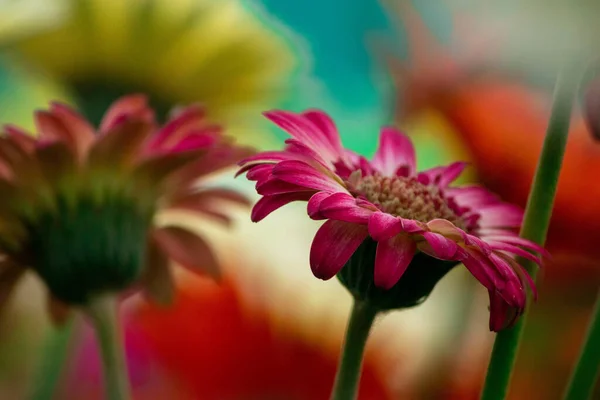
xmin=0 ymin=0 xmax=600 ymax=400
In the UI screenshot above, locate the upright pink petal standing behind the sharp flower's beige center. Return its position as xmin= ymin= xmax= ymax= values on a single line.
xmin=371 ymin=127 xmax=416 ymax=176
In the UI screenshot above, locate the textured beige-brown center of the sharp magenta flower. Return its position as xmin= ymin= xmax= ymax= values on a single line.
xmin=356 ymin=175 xmax=465 ymax=228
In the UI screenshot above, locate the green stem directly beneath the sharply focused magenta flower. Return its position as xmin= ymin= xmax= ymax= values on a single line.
xmin=331 ymin=300 xmax=377 ymax=400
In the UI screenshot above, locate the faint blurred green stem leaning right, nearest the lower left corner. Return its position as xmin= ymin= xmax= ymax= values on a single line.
xmin=29 ymin=318 xmax=75 ymax=400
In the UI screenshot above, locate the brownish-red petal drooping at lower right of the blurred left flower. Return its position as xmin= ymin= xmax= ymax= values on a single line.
xmin=152 ymin=226 xmax=221 ymax=279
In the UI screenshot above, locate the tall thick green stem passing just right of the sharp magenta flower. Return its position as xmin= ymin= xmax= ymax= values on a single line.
xmin=481 ymin=71 xmax=577 ymax=400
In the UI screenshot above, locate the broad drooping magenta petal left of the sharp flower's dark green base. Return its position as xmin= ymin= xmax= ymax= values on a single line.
xmin=310 ymin=220 xmax=368 ymax=280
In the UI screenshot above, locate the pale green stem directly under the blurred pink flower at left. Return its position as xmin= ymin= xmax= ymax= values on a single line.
xmin=85 ymin=295 xmax=130 ymax=400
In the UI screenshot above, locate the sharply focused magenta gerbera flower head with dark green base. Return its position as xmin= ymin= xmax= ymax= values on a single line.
xmin=239 ymin=111 xmax=543 ymax=331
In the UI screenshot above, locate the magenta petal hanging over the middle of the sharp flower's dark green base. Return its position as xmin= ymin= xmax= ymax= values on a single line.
xmin=374 ymin=235 xmax=416 ymax=290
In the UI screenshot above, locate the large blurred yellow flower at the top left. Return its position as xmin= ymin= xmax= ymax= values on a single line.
xmin=5 ymin=0 xmax=296 ymax=141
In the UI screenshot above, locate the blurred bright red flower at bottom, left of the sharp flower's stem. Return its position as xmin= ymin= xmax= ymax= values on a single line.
xmin=128 ymin=280 xmax=392 ymax=400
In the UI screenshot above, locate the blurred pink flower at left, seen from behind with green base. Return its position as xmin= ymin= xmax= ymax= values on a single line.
xmin=0 ymin=96 xmax=251 ymax=319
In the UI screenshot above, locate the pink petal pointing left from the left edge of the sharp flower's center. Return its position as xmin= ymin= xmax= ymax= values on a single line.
xmin=272 ymin=161 xmax=346 ymax=192
